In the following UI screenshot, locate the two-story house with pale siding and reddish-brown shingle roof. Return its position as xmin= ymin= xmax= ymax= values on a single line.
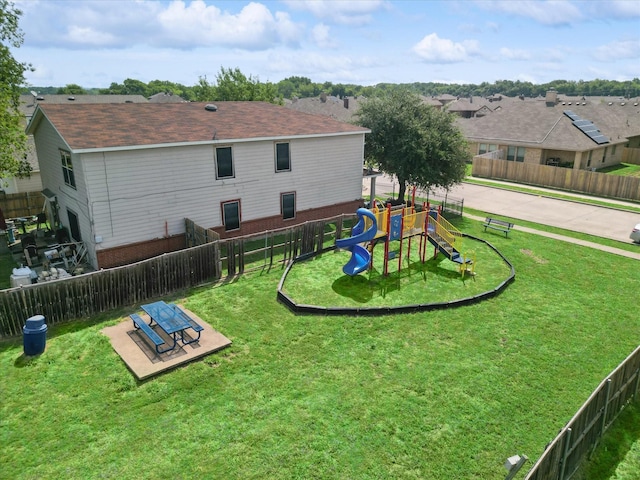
xmin=27 ymin=102 xmax=369 ymax=268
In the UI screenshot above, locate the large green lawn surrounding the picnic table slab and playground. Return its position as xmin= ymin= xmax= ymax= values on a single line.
xmin=0 ymin=219 xmax=640 ymax=480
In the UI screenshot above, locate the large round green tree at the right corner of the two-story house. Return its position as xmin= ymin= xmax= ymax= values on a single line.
xmin=355 ymin=89 xmax=469 ymax=201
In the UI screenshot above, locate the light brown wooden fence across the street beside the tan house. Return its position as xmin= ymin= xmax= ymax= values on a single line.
xmin=472 ymin=156 xmax=640 ymax=201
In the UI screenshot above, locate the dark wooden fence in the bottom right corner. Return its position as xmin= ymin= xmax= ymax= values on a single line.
xmin=525 ymin=347 xmax=640 ymax=480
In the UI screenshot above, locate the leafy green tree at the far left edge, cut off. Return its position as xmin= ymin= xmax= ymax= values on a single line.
xmin=0 ymin=0 xmax=31 ymax=178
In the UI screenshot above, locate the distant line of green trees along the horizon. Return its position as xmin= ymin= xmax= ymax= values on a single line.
xmin=24 ymin=75 xmax=640 ymax=101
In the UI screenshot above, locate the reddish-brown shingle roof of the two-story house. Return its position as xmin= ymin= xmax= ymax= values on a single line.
xmin=29 ymin=102 xmax=369 ymax=150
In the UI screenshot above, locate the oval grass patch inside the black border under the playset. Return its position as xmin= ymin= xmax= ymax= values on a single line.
xmin=283 ymin=237 xmax=511 ymax=308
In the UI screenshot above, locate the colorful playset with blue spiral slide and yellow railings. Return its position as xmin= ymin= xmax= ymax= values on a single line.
xmin=336 ymin=189 xmax=476 ymax=276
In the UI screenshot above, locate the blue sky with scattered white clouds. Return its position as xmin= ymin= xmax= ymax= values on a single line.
xmin=13 ymin=0 xmax=640 ymax=88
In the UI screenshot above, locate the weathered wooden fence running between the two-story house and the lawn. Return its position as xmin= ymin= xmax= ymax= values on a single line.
xmin=0 ymin=216 xmax=353 ymax=337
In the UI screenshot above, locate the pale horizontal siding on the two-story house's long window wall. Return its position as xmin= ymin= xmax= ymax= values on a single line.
xmin=84 ymin=134 xmax=363 ymax=248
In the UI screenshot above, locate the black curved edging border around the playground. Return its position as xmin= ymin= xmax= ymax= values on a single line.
xmin=278 ymin=233 xmax=516 ymax=316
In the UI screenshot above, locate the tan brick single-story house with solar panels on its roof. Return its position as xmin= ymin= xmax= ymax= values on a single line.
xmin=458 ymin=92 xmax=640 ymax=170
